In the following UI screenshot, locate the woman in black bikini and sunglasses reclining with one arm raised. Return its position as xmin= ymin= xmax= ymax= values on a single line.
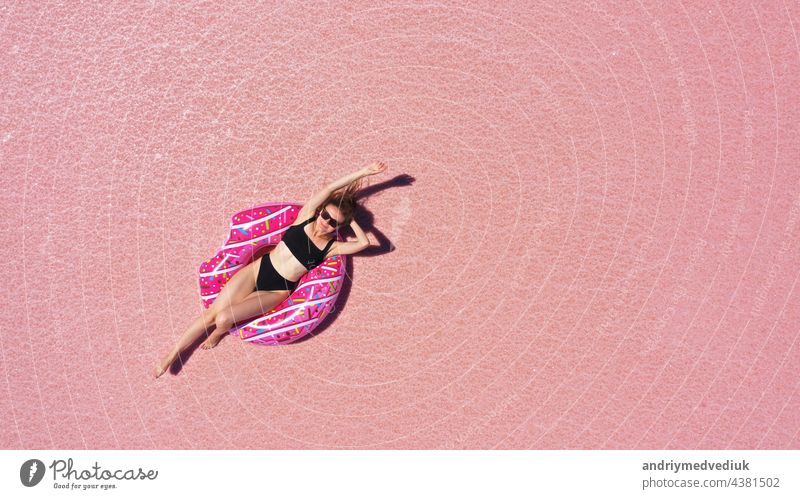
xmin=154 ymin=161 xmax=387 ymax=378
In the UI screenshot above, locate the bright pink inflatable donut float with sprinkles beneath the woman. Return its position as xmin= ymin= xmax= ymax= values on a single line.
xmin=200 ymin=203 xmax=346 ymax=345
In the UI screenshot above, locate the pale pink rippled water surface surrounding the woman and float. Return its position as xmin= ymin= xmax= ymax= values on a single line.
xmin=0 ymin=0 xmax=800 ymax=449
